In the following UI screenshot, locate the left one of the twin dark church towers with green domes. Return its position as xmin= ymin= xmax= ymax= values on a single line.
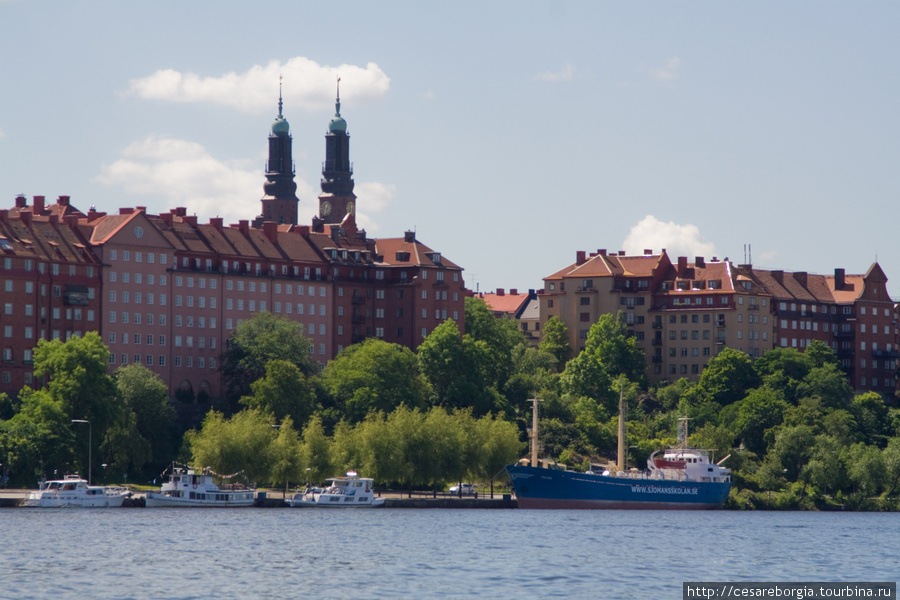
xmin=254 ymin=82 xmax=300 ymax=225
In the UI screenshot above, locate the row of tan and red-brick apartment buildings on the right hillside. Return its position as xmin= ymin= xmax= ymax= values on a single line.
xmin=538 ymin=250 xmax=900 ymax=395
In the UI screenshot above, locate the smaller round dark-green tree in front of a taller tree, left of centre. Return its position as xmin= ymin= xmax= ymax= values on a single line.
xmin=241 ymin=359 xmax=317 ymax=427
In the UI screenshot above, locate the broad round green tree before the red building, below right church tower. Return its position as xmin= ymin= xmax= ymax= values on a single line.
xmin=320 ymin=339 xmax=431 ymax=423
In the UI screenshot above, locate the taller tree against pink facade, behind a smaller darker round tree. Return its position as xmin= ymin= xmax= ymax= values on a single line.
xmin=219 ymin=311 xmax=316 ymax=411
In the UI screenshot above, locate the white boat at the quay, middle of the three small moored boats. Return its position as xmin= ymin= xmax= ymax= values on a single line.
xmin=145 ymin=464 xmax=254 ymax=507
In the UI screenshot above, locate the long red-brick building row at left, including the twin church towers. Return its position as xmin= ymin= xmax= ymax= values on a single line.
xmin=0 ymin=89 xmax=466 ymax=414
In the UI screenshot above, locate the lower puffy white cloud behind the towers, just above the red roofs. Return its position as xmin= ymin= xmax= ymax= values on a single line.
xmin=95 ymin=136 xmax=313 ymax=222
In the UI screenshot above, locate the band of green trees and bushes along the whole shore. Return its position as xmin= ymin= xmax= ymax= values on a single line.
xmin=0 ymin=298 xmax=900 ymax=511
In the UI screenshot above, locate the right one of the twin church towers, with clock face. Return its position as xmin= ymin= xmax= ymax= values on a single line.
xmin=319 ymin=78 xmax=356 ymax=223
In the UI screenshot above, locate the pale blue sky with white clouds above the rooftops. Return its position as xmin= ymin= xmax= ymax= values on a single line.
xmin=0 ymin=0 xmax=900 ymax=299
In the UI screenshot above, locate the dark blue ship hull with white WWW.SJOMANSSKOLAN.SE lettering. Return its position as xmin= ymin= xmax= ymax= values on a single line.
xmin=506 ymin=465 xmax=731 ymax=510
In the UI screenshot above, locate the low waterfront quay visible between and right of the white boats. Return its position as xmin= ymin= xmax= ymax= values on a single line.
xmin=0 ymin=490 xmax=518 ymax=508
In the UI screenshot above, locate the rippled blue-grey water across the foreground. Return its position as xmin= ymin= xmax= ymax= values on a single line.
xmin=0 ymin=508 xmax=900 ymax=600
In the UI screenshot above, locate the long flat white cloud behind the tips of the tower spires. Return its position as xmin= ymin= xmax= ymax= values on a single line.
xmin=126 ymin=56 xmax=390 ymax=114
